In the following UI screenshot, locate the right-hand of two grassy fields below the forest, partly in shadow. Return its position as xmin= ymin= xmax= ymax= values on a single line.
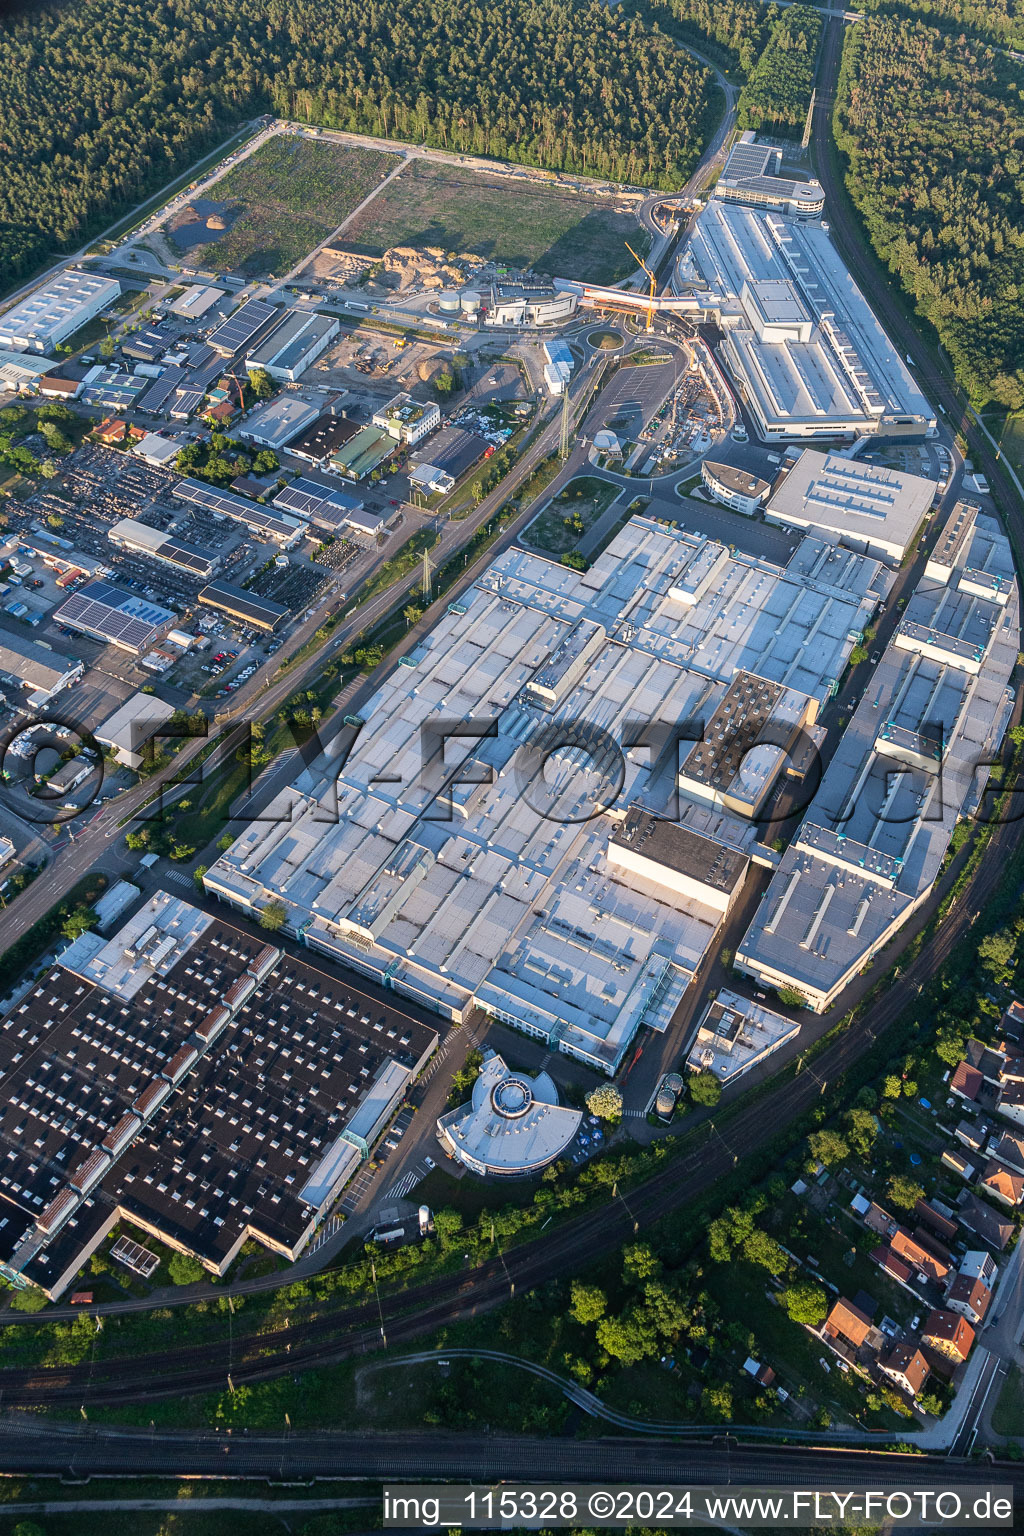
xmin=345 ymin=160 xmax=640 ymax=283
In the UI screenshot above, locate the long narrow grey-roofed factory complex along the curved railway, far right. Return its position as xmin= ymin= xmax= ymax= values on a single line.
xmin=735 ymin=508 xmax=1019 ymax=1012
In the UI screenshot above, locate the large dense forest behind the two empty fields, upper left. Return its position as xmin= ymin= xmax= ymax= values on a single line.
xmin=0 ymin=0 xmax=721 ymax=287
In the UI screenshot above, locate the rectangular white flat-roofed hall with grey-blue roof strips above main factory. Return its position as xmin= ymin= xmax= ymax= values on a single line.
xmin=765 ymin=449 xmax=938 ymax=565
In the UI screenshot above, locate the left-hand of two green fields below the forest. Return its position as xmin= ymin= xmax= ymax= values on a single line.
xmin=174 ymin=134 xmax=395 ymax=276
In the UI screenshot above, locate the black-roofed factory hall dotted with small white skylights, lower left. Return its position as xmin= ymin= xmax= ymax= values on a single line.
xmin=0 ymin=891 xmax=438 ymax=1298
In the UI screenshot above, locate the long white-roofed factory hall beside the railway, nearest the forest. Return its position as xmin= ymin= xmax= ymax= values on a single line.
xmin=672 ymin=198 xmax=935 ymax=441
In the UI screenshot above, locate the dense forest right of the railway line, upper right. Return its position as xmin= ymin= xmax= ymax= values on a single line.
xmin=835 ymin=15 xmax=1024 ymax=409
